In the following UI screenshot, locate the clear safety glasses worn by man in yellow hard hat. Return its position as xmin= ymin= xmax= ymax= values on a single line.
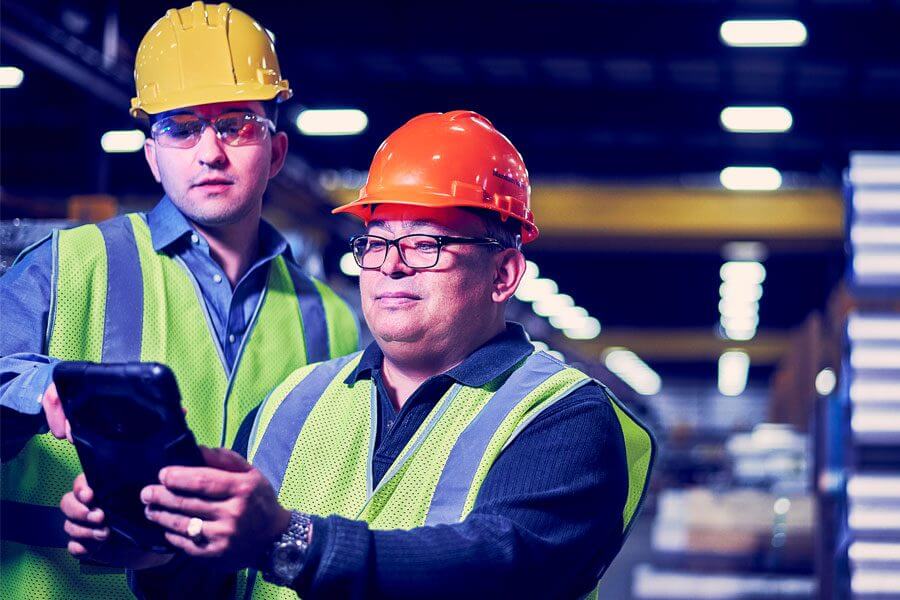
xmin=150 ymin=113 xmax=275 ymax=148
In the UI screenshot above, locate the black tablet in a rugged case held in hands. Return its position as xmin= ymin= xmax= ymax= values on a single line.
xmin=53 ymin=362 xmax=204 ymax=552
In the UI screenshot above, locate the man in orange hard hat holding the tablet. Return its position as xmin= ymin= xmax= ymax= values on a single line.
xmin=64 ymin=111 xmax=654 ymax=598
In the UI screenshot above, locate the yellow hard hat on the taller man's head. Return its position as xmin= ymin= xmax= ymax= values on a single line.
xmin=130 ymin=2 xmax=293 ymax=117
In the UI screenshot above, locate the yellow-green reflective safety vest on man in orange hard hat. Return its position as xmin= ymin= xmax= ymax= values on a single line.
xmin=244 ymin=352 xmax=654 ymax=599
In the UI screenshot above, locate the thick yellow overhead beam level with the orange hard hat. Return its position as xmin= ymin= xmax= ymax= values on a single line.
xmin=334 ymin=182 xmax=844 ymax=250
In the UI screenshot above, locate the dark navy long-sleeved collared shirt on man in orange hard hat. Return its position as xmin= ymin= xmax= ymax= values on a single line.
xmin=133 ymin=323 xmax=628 ymax=598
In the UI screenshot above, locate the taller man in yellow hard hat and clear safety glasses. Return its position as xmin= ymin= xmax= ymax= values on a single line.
xmin=0 ymin=2 xmax=358 ymax=599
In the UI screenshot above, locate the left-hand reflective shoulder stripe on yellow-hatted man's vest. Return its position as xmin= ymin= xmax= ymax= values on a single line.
xmin=97 ymin=217 xmax=144 ymax=362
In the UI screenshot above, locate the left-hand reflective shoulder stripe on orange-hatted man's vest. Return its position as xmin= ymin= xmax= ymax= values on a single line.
xmin=253 ymin=353 xmax=359 ymax=496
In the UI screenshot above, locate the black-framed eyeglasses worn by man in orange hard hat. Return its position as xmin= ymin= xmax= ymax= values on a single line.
xmin=350 ymin=233 xmax=503 ymax=269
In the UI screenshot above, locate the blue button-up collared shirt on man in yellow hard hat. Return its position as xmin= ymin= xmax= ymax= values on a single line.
xmin=0 ymin=197 xmax=292 ymax=454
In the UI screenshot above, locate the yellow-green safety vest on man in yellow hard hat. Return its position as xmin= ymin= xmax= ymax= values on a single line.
xmin=0 ymin=214 xmax=358 ymax=600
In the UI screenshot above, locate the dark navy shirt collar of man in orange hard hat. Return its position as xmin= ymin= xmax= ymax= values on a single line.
xmin=344 ymin=321 xmax=534 ymax=387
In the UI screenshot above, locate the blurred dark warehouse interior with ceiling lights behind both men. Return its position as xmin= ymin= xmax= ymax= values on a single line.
xmin=0 ymin=0 xmax=900 ymax=599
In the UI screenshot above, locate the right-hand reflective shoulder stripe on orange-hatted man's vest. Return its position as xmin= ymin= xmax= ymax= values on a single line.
xmin=425 ymin=352 xmax=566 ymax=525
